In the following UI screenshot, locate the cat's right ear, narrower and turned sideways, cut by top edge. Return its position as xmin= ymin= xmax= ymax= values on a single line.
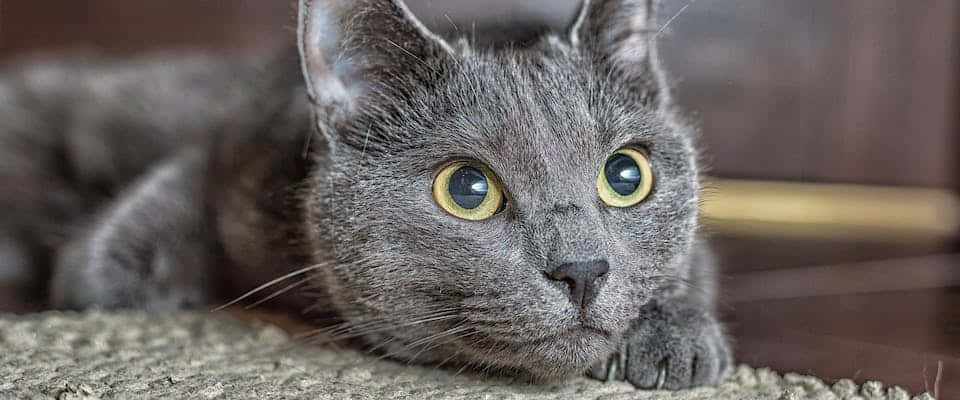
xmin=569 ymin=0 xmax=663 ymax=101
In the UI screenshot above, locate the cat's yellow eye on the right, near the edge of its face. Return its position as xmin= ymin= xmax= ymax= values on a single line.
xmin=597 ymin=147 xmax=653 ymax=207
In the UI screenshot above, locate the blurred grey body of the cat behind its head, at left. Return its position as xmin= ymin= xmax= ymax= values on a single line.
xmin=0 ymin=51 xmax=312 ymax=308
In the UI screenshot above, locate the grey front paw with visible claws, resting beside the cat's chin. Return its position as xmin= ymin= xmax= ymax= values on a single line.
xmin=588 ymin=309 xmax=733 ymax=390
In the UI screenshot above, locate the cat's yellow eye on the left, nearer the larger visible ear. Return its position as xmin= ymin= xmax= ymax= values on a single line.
xmin=433 ymin=162 xmax=504 ymax=221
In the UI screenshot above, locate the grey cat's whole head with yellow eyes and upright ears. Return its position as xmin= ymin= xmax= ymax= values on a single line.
xmin=299 ymin=0 xmax=698 ymax=377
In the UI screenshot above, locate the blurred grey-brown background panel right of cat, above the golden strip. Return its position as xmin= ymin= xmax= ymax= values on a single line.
xmin=661 ymin=0 xmax=960 ymax=187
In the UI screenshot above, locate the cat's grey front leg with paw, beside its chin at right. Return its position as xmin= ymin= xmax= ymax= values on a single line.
xmin=588 ymin=245 xmax=733 ymax=389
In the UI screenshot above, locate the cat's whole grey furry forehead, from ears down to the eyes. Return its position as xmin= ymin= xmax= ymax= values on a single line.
xmin=334 ymin=33 xmax=685 ymax=180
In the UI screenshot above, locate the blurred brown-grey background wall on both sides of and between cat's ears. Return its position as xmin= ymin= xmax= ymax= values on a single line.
xmin=0 ymin=0 xmax=960 ymax=187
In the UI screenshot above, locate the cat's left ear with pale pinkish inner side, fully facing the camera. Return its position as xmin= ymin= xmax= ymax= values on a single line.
xmin=297 ymin=0 xmax=452 ymax=122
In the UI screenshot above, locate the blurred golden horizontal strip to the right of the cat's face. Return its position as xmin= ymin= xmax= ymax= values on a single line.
xmin=701 ymin=179 xmax=960 ymax=241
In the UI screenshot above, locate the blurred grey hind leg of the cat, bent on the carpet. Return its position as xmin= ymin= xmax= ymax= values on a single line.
xmin=51 ymin=149 xmax=215 ymax=310
